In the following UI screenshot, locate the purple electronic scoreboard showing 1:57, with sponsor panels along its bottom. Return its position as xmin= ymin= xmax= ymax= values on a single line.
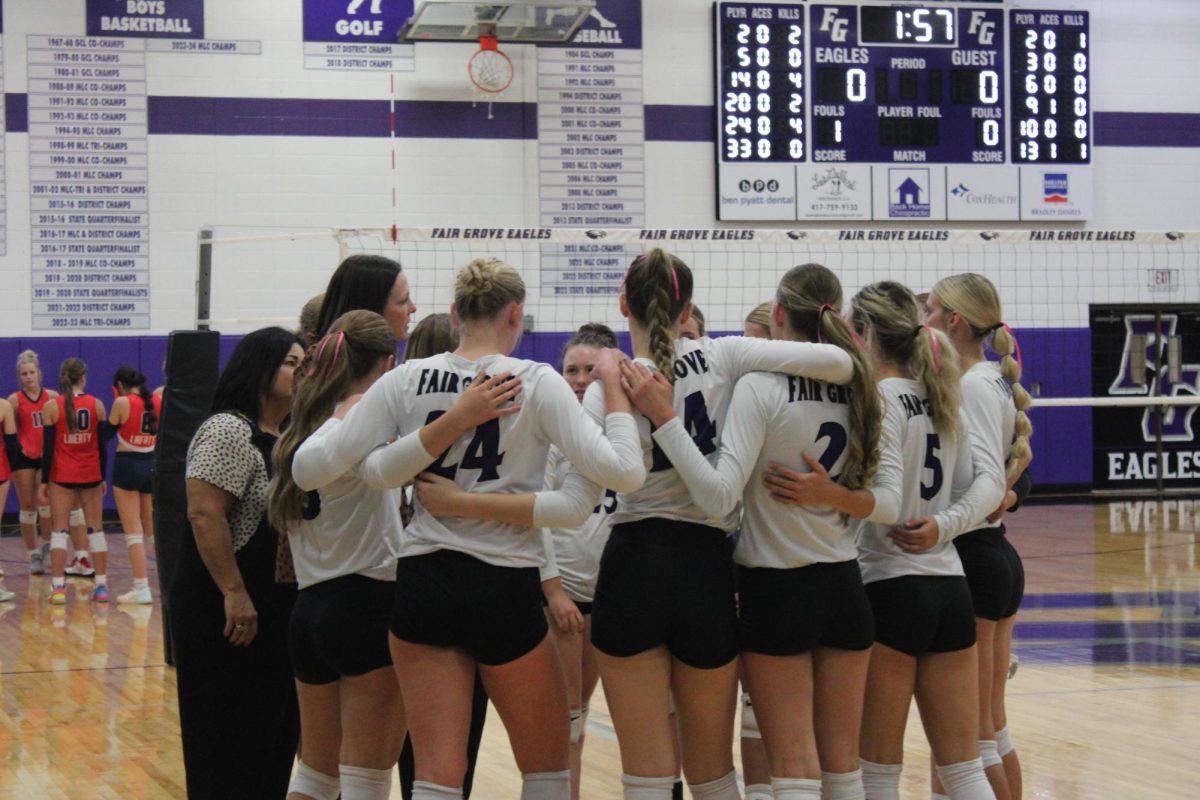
xmin=715 ymin=0 xmax=1092 ymax=221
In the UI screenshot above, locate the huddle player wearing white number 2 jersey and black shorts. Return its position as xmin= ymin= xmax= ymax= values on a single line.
xmin=630 ymin=264 xmax=880 ymax=800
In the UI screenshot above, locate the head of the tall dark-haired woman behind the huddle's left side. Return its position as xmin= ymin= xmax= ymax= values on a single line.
xmin=316 ymin=254 xmax=416 ymax=342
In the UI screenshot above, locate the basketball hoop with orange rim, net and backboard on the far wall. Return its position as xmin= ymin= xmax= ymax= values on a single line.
xmin=396 ymin=0 xmax=596 ymax=119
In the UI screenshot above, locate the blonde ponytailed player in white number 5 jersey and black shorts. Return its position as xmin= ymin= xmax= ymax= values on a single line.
xmin=770 ymin=282 xmax=1003 ymax=800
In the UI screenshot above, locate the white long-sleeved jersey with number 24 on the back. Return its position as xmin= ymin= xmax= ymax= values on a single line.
xmin=296 ymin=353 xmax=644 ymax=567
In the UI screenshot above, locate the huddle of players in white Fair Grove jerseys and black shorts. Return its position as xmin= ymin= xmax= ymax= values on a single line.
xmin=269 ymin=249 xmax=1031 ymax=800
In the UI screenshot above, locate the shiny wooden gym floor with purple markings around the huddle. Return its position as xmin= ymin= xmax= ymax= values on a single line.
xmin=0 ymin=500 xmax=1200 ymax=800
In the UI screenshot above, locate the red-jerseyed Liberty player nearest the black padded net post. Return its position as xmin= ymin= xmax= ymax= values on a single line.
xmin=108 ymin=367 xmax=162 ymax=606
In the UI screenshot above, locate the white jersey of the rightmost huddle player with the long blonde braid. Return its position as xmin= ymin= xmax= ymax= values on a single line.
xmin=962 ymin=361 xmax=1016 ymax=530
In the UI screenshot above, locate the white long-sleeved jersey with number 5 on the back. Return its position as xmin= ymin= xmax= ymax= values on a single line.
xmin=858 ymin=378 xmax=1004 ymax=583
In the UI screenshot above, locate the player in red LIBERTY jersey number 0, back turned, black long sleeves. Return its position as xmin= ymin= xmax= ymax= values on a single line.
xmin=42 ymin=359 xmax=108 ymax=606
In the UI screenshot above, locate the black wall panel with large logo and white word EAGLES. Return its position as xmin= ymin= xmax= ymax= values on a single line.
xmin=1091 ymin=303 xmax=1200 ymax=489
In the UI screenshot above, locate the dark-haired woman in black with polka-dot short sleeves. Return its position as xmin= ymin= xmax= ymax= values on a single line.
xmin=169 ymin=327 xmax=304 ymax=800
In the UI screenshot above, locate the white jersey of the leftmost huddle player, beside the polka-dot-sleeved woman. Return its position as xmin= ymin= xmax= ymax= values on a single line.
xmin=288 ymin=419 xmax=403 ymax=589
